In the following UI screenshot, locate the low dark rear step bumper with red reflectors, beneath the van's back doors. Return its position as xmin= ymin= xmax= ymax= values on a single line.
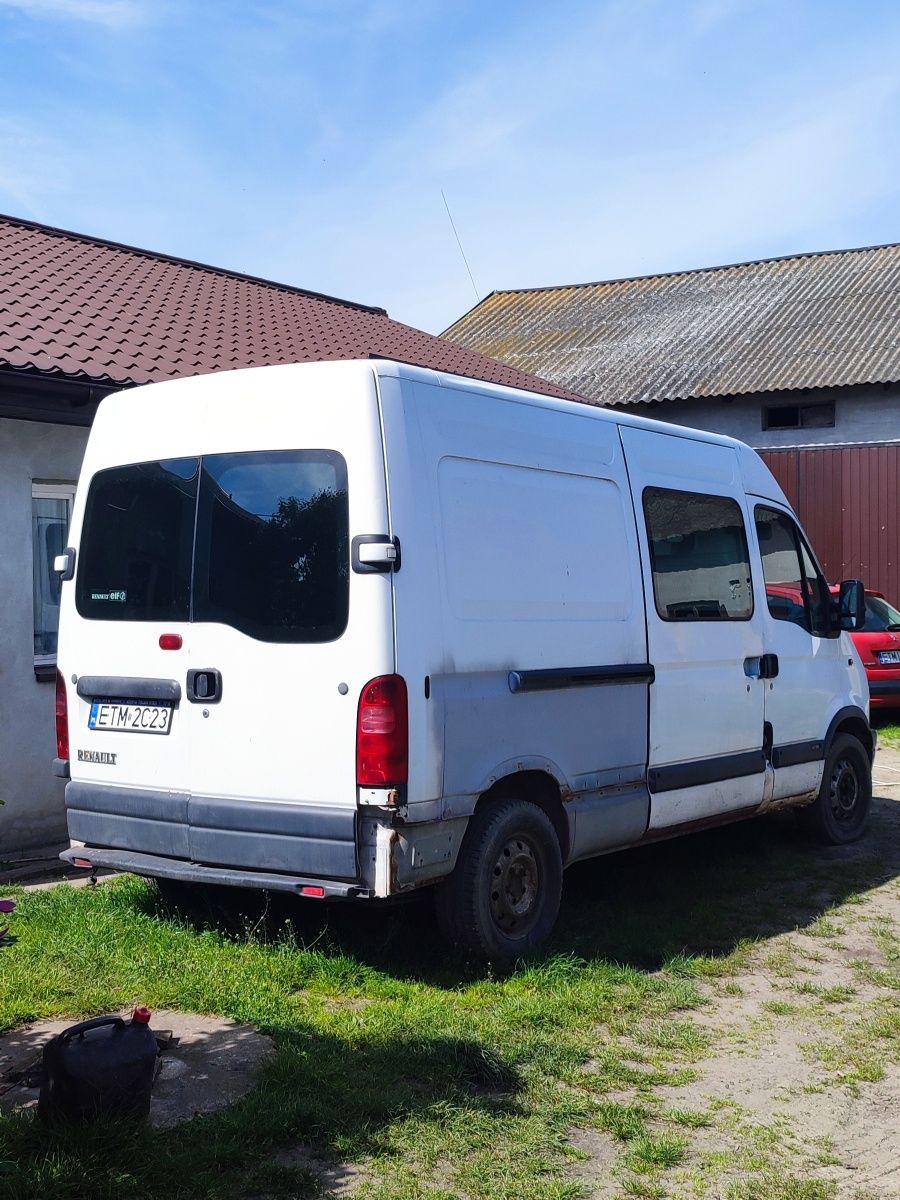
xmin=60 ymin=846 xmax=372 ymax=899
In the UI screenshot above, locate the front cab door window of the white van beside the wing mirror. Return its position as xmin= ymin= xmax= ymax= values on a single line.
xmin=756 ymin=505 xmax=830 ymax=634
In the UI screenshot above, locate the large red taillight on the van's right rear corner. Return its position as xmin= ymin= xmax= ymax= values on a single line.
xmin=356 ymin=676 xmax=409 ymax=787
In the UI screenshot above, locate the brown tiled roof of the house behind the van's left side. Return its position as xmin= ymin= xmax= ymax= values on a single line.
xmin=0 ymin=216 xmax=571 ymax=396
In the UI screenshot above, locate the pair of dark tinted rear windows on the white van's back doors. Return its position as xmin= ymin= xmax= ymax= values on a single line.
xmin=76 ymin=450 xmax=349 ymax=642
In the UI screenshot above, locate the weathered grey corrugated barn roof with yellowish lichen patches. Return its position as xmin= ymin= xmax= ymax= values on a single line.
xmin=443 ymin=245 xmax=900 ymax=404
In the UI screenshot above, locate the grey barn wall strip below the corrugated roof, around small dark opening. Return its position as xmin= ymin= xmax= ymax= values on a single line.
xmin=626 ymin=384 xmax=900 ymax=450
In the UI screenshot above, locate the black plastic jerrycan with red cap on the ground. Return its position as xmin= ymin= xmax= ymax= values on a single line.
xmin=37 ymin=1008 xmax=158 ymax=1122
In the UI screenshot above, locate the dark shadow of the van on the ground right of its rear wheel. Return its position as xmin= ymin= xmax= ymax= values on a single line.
xmin=554 ymin=798 xmax=900 ymax=971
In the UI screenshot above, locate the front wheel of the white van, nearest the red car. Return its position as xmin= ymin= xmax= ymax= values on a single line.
xmin=797 ymin=733 xmax=872 ymax=846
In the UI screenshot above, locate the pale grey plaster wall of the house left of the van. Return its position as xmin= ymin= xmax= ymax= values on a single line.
xmin=0 ymin=418 xmax=88 ymax=860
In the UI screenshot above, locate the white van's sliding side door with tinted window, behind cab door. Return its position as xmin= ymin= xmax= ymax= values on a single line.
xmin=620 ymin=426 xmax=767 ymax=829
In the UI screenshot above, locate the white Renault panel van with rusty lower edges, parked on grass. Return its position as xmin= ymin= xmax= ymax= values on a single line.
xmin=55 ymin=360 xmax=874 ymax=958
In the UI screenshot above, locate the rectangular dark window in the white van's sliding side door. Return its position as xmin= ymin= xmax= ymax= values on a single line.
xmin=643 ymin=487 xmax=754 ymax=620
